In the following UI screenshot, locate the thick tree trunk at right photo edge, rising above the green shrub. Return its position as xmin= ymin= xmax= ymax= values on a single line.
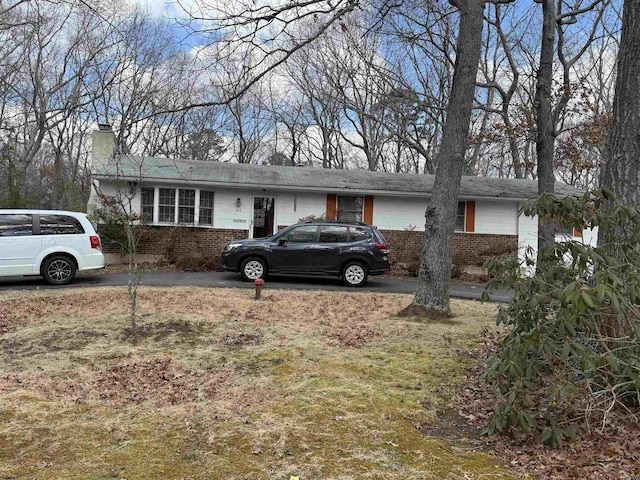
xmin=600 ymin=0 xmax=640 ymax=207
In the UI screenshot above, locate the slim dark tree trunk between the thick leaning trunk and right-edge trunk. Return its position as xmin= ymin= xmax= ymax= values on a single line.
xmin=535 ymin=0 xmax=556 ymax=252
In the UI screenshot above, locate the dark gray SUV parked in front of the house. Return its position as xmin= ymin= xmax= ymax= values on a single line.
xmin=220 ymin=221 xmax=390 ymax=287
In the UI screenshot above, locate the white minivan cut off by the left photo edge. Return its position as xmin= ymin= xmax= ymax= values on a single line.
xmin=0 ymin=209 xmax=105 ymax=285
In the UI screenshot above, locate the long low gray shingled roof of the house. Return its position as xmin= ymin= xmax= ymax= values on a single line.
xmin=94 ymin=155 xmax=581 ymax=200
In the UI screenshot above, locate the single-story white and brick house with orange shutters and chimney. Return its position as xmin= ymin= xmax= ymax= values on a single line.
xmin=88 ymin=126 xmax=591 ymax=263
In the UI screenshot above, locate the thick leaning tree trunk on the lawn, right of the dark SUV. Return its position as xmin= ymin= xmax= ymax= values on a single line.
xmin=413 ymin=0 xmax=485 ymax=315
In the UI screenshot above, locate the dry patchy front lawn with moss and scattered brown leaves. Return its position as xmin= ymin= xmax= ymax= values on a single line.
xmin=0 ymin=288 xmax=521 ymax=480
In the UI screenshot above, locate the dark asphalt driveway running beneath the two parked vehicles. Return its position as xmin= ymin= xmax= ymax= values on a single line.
xmin=0 ymin=270 xmax=512 ymax=302
